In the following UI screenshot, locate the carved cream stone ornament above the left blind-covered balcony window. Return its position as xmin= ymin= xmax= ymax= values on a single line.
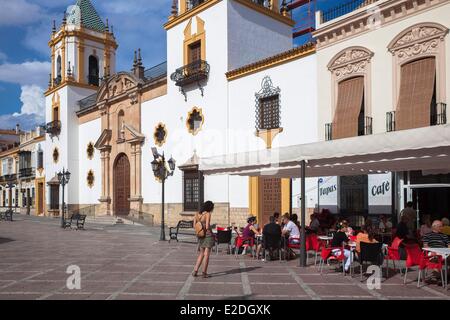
xmin=328 ymin=47 xmax=373 ymax=80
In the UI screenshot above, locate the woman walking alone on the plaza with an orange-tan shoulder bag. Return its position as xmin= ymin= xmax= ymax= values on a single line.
xmin=192 ymin=201 xmax=215 ymax=278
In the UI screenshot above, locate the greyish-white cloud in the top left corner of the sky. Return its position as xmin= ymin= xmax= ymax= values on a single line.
xmin=0 ymin=0 xmax=43 ymax=26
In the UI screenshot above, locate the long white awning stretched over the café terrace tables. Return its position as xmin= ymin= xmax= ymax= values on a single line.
xmin=199 ymin=124 xmax=450 ymax=178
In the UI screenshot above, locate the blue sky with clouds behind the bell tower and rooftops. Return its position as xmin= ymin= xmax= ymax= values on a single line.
xmin=0 ymin=0 xmax=358 ymax=129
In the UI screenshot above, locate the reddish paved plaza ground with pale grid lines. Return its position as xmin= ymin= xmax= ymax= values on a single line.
xmin=0 ymin=215 xmax=450 ymax=300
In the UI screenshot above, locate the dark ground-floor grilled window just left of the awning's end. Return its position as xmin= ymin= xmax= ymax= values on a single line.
xmin=183 ymin=170 xmax=204 ymax=211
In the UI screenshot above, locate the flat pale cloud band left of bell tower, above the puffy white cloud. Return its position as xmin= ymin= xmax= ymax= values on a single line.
xmin=0 ymin=61 xmax=51 ymax=88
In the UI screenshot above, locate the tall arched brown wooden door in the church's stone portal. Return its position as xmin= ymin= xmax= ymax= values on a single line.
xmin=113 ymin=153 xmax=130 ymax=216
